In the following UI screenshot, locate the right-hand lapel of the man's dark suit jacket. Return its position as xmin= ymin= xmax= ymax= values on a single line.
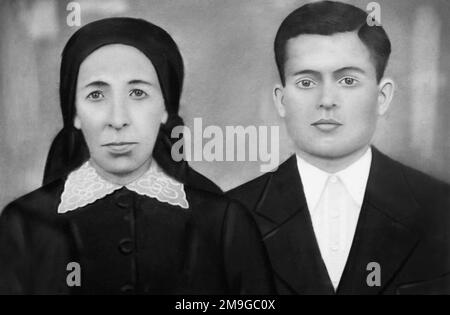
xmin=337 ymin=148 xmax=419 ymax=294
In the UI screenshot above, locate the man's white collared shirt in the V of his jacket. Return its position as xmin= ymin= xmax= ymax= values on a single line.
xmin=297 ymin=148 xmax=372 ymax=289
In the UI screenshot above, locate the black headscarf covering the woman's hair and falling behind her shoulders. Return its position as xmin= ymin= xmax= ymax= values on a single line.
xmin=43 ymin=18 xmax=220 ymax=192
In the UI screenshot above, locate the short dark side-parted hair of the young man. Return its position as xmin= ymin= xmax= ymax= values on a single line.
xmin=274 ymin=1 xmax=391 ymax=85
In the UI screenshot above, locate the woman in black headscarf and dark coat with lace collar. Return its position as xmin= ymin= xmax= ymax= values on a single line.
xmin=0 ymin=18 xmax=272 ymax=294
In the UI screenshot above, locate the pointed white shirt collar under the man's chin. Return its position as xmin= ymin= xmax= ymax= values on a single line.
xmin=297 ymin=147 xmax=372 ymax=211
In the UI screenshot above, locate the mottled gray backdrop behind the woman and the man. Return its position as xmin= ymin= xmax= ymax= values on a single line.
xmin=0 ymin=0 xmax=450 ymax=209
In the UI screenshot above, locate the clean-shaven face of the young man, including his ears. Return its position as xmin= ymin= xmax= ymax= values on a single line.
xmin=274 ymin=32 xmax=392 ymax=163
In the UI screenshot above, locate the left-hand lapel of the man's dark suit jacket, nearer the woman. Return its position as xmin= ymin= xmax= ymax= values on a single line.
xmin=255 ymin=155 xmax=334 ymax=294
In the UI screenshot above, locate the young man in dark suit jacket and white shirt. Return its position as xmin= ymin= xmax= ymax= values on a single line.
xmin=227 ymin=1 xmax=450 ymax=294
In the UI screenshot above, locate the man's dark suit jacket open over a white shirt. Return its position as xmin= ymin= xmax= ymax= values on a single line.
xmin=227 ymin=148 xmax=450 ymax=294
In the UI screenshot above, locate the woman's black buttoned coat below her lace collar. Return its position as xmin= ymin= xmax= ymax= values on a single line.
xmin=0 ymin=180 xmax=273 ymax=294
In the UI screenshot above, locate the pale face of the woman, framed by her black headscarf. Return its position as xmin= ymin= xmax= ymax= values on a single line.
xmin=74 ymin=44 xmax=167 ymax=184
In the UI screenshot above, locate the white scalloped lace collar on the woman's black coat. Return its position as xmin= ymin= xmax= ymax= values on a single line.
xmin=58 ymin=161 xmax=189 ymax=213
